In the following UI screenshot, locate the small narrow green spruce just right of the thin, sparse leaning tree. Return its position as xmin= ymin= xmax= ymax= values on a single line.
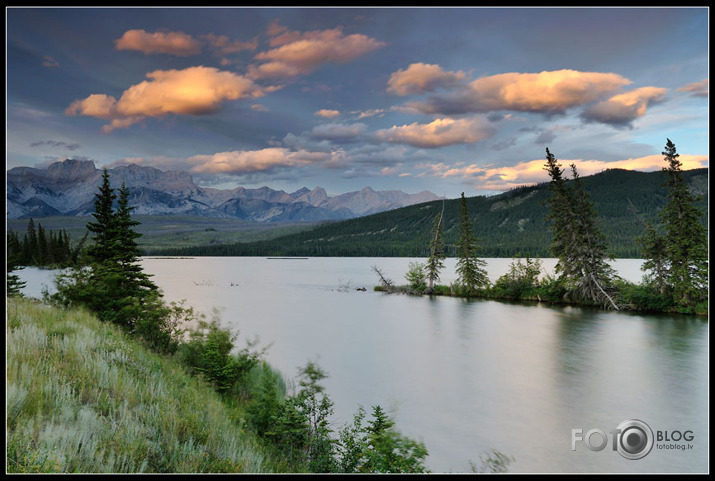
xmin=457 ymin=192 xmax=489 ymax=295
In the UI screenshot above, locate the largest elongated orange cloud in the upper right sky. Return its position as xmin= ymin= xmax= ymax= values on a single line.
xmin=408 ymin=70 xmax=631 ymax=114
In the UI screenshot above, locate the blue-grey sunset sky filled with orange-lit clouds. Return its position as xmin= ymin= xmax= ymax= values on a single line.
xmin=6 ymin=7 xmax=709 ymax=198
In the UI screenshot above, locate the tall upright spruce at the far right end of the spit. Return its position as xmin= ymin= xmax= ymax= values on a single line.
xmin=661 ymin=139 xmax=708 ymax=308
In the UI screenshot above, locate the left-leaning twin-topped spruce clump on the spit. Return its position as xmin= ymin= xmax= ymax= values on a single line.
xmin=544 ymin=148 xmax=618 ymax=309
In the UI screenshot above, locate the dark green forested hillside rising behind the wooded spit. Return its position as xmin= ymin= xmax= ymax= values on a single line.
xmin=151 ymin=169 xmax=708 ymax=258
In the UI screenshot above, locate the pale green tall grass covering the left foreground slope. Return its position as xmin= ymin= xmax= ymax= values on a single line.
xmin=6 ymin=298 xmax=273 ymax=473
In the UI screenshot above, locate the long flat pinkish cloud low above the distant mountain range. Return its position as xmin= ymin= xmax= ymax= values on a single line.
xmin=187 ymin=147 xmax=330 ymax=175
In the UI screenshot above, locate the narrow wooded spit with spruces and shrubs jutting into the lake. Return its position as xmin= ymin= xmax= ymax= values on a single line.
xmin=373 ymin=140 xmax=709 ymax=315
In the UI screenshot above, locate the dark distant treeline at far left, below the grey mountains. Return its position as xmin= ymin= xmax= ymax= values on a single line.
xmin=7 ymin=219 xmax=87 ymax=267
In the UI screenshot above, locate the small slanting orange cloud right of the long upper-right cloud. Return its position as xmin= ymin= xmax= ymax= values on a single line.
xmin=581 ymin=87 xmax=667 ymax=126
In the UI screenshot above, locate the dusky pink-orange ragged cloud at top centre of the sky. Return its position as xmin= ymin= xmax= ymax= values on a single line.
xmin=249 ymin=22 xmax=385 ymax=79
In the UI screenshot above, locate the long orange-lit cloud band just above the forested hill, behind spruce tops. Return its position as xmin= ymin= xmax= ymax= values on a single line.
xmin=420 ymin=154 xmax=708 ymax=192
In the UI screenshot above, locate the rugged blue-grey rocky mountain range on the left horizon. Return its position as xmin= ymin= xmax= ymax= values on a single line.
xmin=6 ymin=159 xmax=440 ymax=223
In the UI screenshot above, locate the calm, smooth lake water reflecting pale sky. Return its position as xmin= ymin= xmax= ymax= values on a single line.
xmin=20 ymin=257 xmax=709 ymax=473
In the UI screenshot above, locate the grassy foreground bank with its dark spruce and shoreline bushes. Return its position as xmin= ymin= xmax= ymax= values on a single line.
xmin=6 ymin=171 xmax=511 ymax=473
